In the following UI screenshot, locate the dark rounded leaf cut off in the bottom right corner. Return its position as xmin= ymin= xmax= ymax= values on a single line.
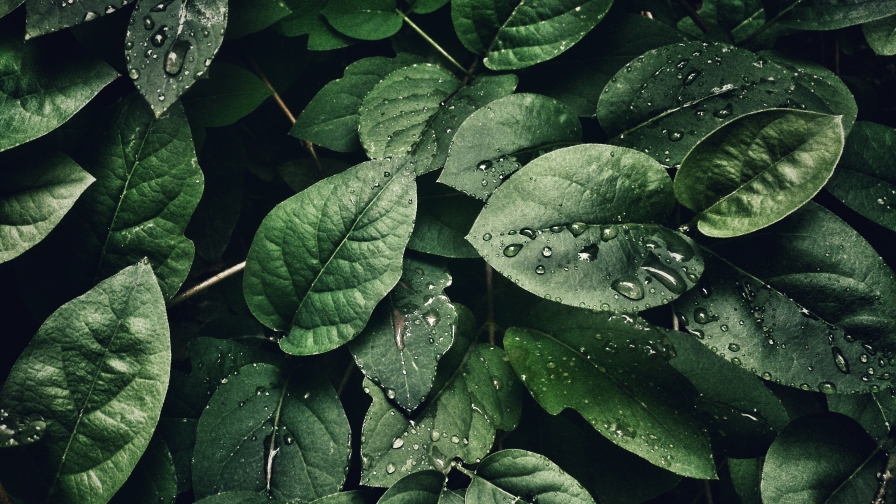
xmin=762 ymin=413 xmax=886 ymax=504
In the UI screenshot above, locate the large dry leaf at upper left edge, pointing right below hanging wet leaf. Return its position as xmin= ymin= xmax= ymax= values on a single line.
xmin=0 ymin=32 xmax=118 ymax=151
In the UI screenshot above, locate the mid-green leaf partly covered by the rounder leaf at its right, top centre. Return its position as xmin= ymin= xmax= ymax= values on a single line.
xmin=289 ymin=54 xmax=421 ymax=152
